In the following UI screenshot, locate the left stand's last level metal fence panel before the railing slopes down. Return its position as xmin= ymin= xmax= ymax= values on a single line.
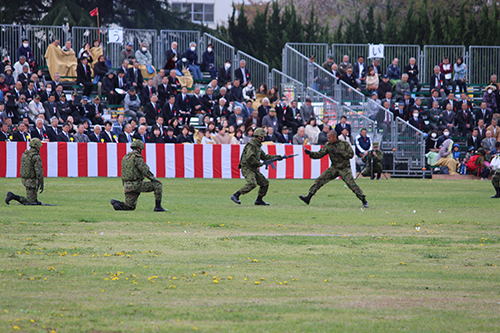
xmin=157 ymin=30 xmax=200 ymax=69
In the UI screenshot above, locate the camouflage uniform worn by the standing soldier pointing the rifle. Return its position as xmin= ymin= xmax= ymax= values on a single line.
xmin=238 ymin=138 xmax=279 ymax=197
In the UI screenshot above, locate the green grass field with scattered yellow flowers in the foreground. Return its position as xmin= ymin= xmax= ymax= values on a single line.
xmin=0 ymin=178 xmax=500 ymax=332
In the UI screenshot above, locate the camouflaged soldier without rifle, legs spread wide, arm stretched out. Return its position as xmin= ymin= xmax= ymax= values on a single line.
xmin=299 ymin=131 xmax=368 ymax=208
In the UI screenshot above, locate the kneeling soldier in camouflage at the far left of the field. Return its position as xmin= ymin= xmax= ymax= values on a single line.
xmin=5 ymin=138 xmax=43 ymax=205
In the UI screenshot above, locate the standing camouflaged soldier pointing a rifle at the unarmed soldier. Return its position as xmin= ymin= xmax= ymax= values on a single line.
xmin=231 ymin=128 xmax=283 ymax=206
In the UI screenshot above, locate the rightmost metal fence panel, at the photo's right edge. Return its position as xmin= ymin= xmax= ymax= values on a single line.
xmin=465 ymin=45 xmax=500 ymax=84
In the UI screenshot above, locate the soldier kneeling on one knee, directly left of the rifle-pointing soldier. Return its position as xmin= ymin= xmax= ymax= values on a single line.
xmin=111 ymin=140 xmax=167 ymax=212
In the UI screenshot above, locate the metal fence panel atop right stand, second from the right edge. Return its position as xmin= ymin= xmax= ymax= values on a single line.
xmin=422 ymin=45 xmax=466 ymax=83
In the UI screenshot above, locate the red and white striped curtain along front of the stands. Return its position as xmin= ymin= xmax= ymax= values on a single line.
xmin=0 ymin=142 xmax=355 ymax=179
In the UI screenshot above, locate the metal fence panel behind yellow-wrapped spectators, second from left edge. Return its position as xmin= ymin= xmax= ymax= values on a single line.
xmin=25 ymin=25 xmax=69 ymax=66
